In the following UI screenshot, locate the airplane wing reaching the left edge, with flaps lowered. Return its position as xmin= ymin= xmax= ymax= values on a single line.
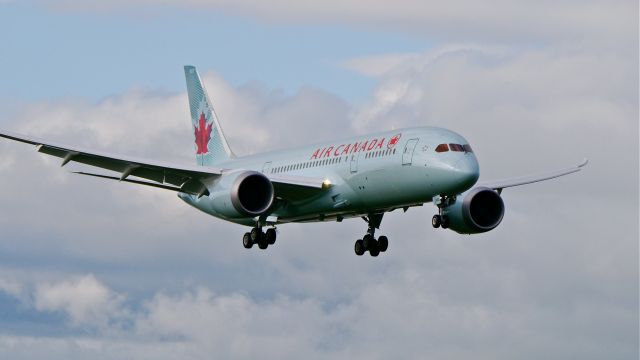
xmin=0 ymin=130 xmax=326 ymax=198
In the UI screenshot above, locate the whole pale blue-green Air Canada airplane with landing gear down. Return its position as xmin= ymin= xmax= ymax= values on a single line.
xmin=0 ymin=66 xmax=587 ymax=257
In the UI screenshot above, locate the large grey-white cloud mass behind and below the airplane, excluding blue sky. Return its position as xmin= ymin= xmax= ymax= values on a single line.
xmin=0 ymin=12 xmax=638 ymax=359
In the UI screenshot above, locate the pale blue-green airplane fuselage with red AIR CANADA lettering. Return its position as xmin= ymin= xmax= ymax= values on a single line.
xmin=180 ymin=127 xmax=479 ymax=225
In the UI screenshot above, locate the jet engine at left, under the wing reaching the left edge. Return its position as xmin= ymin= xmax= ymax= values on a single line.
xmin=210 ymin=171 xmax=275 ymax=219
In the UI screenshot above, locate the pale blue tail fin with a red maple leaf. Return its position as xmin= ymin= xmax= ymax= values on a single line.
xmin=184 ymin=65 xmax=235 ymax=166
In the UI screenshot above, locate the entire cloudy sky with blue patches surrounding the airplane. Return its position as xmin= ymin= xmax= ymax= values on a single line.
xmin=0 ymin=0 xmax=639 ymax=359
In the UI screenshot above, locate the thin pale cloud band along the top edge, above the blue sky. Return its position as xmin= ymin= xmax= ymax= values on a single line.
xmin=44 ymin=0 xmax=638 ymax=45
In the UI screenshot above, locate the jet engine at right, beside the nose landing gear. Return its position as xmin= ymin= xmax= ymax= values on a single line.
xmin=442 ymin=187 xmax=504 ymax=234
